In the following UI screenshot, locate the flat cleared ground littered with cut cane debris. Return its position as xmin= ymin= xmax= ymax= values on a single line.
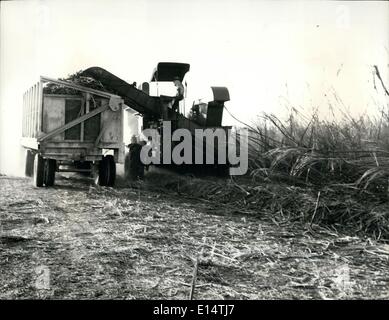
xmin=0 ymin=175 xmax=389 ymax=299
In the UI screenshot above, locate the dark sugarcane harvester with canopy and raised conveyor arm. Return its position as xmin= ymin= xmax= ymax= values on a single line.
xmin=83 ymin=62 xmax=231 ymax=179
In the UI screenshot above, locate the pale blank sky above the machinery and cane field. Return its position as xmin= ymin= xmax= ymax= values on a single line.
xmin=0 ymin=0 xmax=389 ymax=175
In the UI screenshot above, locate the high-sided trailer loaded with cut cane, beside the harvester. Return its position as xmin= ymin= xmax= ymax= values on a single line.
xmin=21 ymin=77 xmax=125 ymax=187
